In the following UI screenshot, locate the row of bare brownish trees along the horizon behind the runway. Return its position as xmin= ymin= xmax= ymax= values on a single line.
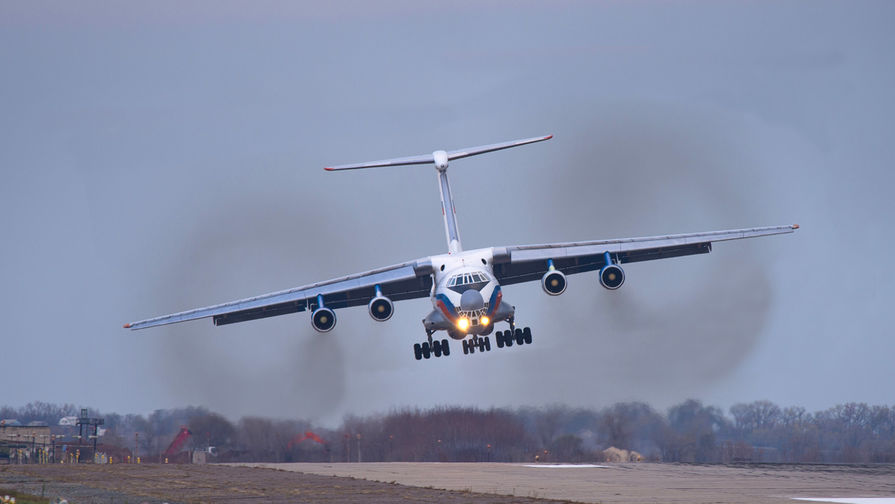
xmin=0 ymin=400 xmax=895 ymax=463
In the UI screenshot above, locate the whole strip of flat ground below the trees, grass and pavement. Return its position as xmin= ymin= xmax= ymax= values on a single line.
xmin=0 ymin=463 xmax=895 ymax=504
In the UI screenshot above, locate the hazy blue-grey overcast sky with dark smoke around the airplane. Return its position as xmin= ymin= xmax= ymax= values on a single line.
xmin=0 ymin=1 xmax=895 ymax=423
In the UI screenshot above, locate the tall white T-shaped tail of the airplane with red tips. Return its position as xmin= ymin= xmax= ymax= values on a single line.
xmin=324 ymin=135 xmax=553 ymax=254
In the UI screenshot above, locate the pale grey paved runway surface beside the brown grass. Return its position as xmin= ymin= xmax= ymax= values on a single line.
xmin=243 ymin=462 xmax=895 ymax=504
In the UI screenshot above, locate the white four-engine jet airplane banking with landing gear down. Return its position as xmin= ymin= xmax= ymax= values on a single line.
xmin=124 ymin=135 xmax=799 ymax=360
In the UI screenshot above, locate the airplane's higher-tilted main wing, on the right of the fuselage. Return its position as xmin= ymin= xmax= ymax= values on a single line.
xmin=493 ymin=224 xmax=799 ymax=285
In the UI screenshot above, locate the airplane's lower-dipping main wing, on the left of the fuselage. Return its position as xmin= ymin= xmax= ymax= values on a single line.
xmin=124 ymin=258 xmax=434 ymax=329
